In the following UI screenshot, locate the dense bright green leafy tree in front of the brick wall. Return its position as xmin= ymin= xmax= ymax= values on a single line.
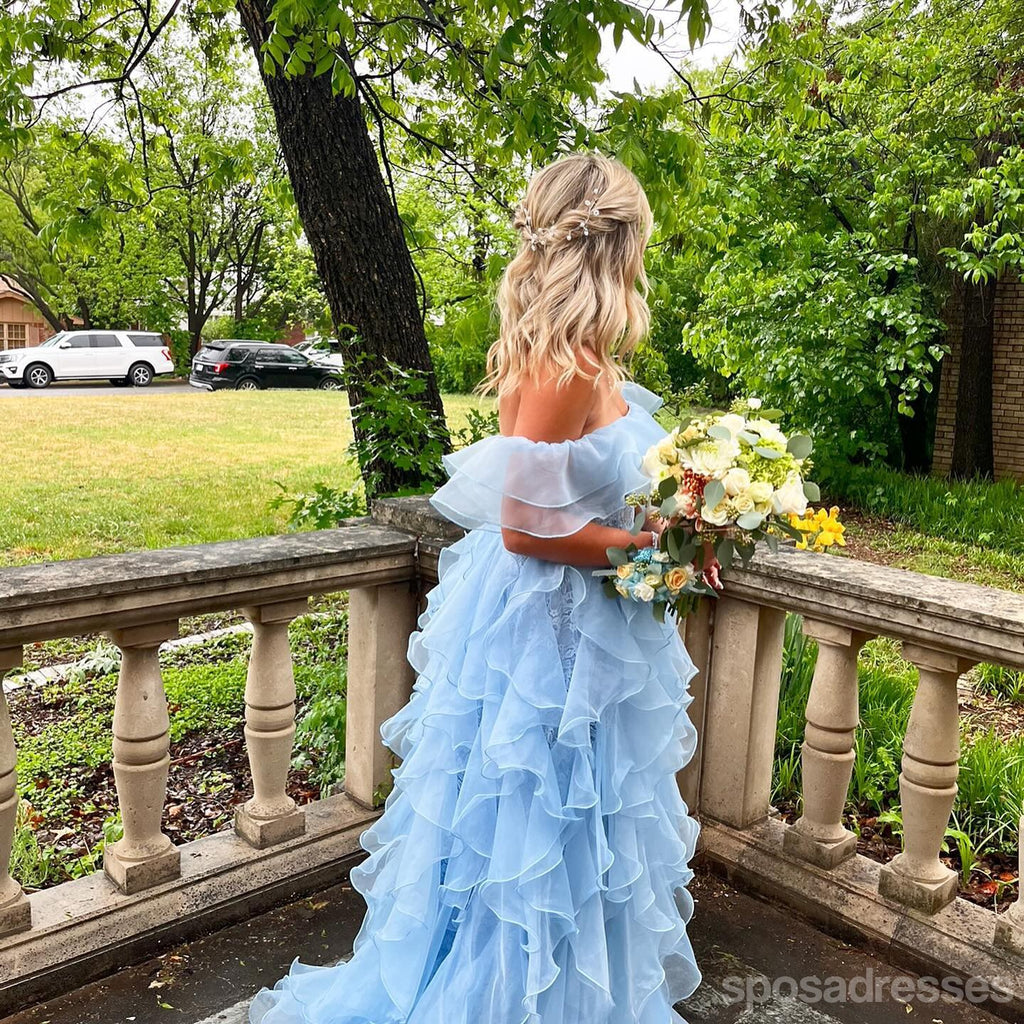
xmin=667 ymin=0 xmax=1024 ymax=475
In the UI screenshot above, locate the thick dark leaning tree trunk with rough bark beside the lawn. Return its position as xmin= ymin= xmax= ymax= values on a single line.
xmin=237 ymin=0 xmax=446 ymax=494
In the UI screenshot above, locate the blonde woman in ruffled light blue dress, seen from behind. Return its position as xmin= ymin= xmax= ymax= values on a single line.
xmin=250 ymin=155 xmax=700 ymax=1024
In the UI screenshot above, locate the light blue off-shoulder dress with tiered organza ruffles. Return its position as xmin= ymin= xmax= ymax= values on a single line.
xmin=250 ymin=383 xmax=700 ymax=1024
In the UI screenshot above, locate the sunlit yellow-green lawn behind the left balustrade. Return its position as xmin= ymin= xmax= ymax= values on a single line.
xmin=0 ymin=391 xmax=493 ymax=565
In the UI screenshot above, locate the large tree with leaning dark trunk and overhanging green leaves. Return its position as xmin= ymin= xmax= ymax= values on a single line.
xmin=0 ymin=0 xmax=712 ymax=488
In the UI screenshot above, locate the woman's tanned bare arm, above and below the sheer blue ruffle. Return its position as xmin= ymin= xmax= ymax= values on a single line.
xmin=502 ymin=364 xmax=653 ymax=566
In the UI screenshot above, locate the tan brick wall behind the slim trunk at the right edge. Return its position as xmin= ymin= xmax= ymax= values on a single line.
xmin=932 ymin=278 xmax=1024 ymax=481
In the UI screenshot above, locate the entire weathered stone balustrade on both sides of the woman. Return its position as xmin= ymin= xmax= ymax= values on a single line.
xmin=0 ymin=499 xmax=1024 ymax=1015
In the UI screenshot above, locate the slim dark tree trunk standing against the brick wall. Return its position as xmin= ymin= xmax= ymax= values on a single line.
xmin=949 ymin=276 xmax=997 ymax=479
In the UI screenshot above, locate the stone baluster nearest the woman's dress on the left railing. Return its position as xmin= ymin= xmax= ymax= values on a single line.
xmin=234 ymin=600 xmax=308 ymax=850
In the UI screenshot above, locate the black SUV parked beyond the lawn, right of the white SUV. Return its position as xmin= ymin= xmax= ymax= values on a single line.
xmin=188 ymin=339 xmax=344 ymax=391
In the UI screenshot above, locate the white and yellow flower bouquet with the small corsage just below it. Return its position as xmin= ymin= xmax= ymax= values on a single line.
xmin=596 ymin=398 xmax=845 ymax=620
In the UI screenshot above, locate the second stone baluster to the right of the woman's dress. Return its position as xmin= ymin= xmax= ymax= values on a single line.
xmin=879 ymin=643 xmax=971 ymax=913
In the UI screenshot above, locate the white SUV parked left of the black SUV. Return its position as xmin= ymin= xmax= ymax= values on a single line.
xmin=0 ymin=331 xmax=174 ymax=388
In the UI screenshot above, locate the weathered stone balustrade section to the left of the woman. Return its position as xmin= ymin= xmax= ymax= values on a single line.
xmin=0 ymin=520 xmax=419 ymax=1016
